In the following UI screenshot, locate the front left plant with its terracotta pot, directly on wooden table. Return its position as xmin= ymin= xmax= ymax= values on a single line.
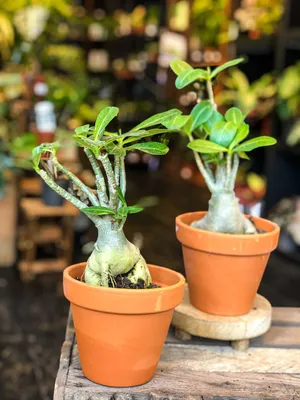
xmin=33 ymin=107 xmax=184 ymax=386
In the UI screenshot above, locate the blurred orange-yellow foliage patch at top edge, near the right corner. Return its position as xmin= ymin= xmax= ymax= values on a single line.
xmin=234 ymin=0 xmax=284 ymax=37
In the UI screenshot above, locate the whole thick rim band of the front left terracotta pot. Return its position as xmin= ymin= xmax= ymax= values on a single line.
xmin=63 ymin=263 xmax=185 ymax=314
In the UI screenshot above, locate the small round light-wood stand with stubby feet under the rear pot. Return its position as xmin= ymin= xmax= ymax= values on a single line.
xmin=172 ymin=285 xmax=272 ymax=350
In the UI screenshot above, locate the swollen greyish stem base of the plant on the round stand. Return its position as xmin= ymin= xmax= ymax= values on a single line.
xmin=192 ymin=190 xmax=256 ymax=234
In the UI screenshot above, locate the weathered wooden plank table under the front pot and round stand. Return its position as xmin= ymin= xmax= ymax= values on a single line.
xmin=54 ymin=308 xmax=300 ymax=400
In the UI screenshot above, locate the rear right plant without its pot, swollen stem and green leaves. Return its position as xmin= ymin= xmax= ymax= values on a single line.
xmin=169 ymin=59 xmax=276 ymax=234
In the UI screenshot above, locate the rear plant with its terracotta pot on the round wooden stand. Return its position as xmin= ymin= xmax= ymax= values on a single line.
xmin=165 ymin=59 xmax=279 ymax=316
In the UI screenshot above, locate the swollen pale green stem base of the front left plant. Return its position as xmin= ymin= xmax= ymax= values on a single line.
xmin=85 ymin=218 xmax=151 ymax=287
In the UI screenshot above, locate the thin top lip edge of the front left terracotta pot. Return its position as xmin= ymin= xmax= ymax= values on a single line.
xmin=63 ymin=262 xmax=185 ymax=295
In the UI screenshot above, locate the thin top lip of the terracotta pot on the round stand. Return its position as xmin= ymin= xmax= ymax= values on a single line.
xmin=176 ymin=211 xmax=280 ymax=240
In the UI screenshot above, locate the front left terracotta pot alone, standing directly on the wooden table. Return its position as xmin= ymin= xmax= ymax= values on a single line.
xmin=64 ymin=263 xmax=185 ymax=387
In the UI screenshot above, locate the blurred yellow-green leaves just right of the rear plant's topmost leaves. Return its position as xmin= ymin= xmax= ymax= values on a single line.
xmin=216 ymin=68 xmax=277 ymax=119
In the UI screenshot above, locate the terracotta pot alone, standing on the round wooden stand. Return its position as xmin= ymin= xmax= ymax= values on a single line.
xmin=176 ymin=212 xmax=279 ymax=316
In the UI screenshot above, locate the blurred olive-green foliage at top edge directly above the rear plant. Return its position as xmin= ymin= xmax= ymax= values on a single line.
xmin=191 ymin=0 xmax=229 ymax=47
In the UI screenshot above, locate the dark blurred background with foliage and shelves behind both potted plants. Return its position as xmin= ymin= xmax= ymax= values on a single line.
xmin=0 ymin=0 xmax=300 ymax=400
